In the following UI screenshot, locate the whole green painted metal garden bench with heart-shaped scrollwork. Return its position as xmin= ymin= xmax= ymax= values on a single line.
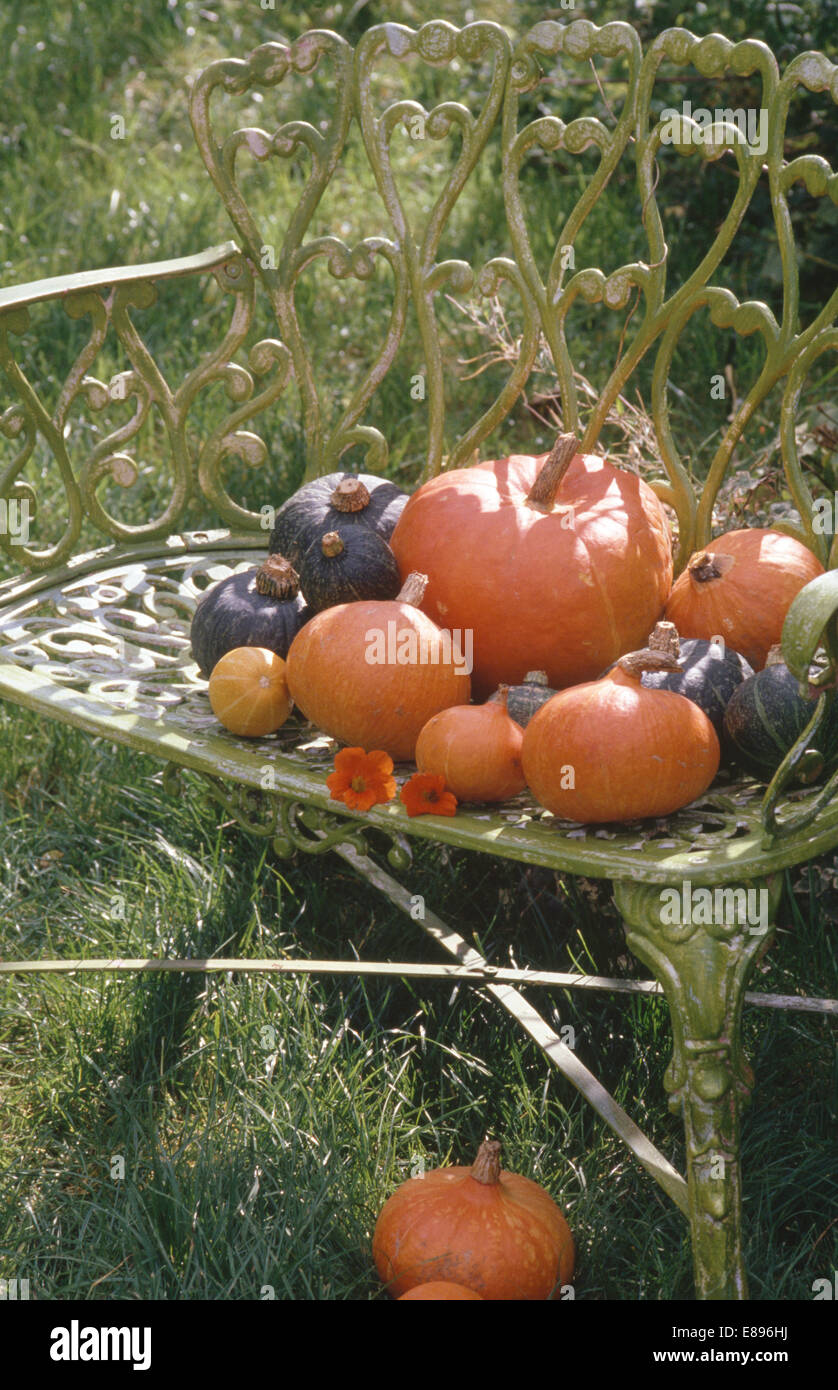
xmin=0 ymin=19 xmax=838 ymax=1298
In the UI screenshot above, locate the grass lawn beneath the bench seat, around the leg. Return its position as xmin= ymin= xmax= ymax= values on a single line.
xmin=0 ymin=708 xmax=838 ymax=1300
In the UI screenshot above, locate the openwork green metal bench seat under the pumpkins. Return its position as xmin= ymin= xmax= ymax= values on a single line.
xmin=0 ymin=531 xmax=838 ymax=887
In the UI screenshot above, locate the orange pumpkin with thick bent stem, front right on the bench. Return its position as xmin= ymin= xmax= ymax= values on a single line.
xmin=523 ymin=649 xmax=720 ymax=821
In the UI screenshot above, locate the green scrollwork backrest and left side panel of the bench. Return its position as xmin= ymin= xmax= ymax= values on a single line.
xmin=0 ymin=19 xmax=838 ymax=569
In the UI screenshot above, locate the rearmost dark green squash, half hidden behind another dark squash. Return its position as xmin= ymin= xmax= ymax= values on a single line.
xmin=268 ymin=473 xmax=407 ymax=569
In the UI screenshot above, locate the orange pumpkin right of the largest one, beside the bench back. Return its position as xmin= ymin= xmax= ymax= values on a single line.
xmin=666 ymin=527 xmax=824 ymax=670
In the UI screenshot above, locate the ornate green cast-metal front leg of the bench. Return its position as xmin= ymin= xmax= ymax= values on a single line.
xmin=614 ymin=874 xmax=781 ymax=1300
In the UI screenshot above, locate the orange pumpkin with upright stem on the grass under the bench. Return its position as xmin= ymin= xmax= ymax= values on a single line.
xmin=372 ymin=1140 xmax=575 ymax=1300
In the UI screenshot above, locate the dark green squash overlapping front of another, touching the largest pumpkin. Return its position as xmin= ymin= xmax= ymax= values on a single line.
xmin=300 ymin=524 xmax=402 ymax=613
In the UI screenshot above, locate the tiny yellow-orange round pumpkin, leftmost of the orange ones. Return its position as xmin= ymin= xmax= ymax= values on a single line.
xmin=210 ymin=646 xmax=293 ymax=738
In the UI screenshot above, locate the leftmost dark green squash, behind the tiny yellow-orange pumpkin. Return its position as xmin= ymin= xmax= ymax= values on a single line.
xmin=189 ymin=555 xmax=311 ymax=680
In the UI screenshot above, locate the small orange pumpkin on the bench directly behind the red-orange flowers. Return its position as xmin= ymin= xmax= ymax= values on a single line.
xmin=416 ymin=685 xmax=527 ymax=801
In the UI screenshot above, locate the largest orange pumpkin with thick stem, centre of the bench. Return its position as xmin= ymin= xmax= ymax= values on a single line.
xmin=391 ymin=435 xmax=673 ymax=699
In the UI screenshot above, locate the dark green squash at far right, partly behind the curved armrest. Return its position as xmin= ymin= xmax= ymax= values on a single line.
xmin=724 ymin=648 xmax=838 ymax=784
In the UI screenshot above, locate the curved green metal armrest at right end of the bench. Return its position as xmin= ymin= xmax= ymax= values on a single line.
xmin=762 ymin=570 xmax=838 ymax=840
